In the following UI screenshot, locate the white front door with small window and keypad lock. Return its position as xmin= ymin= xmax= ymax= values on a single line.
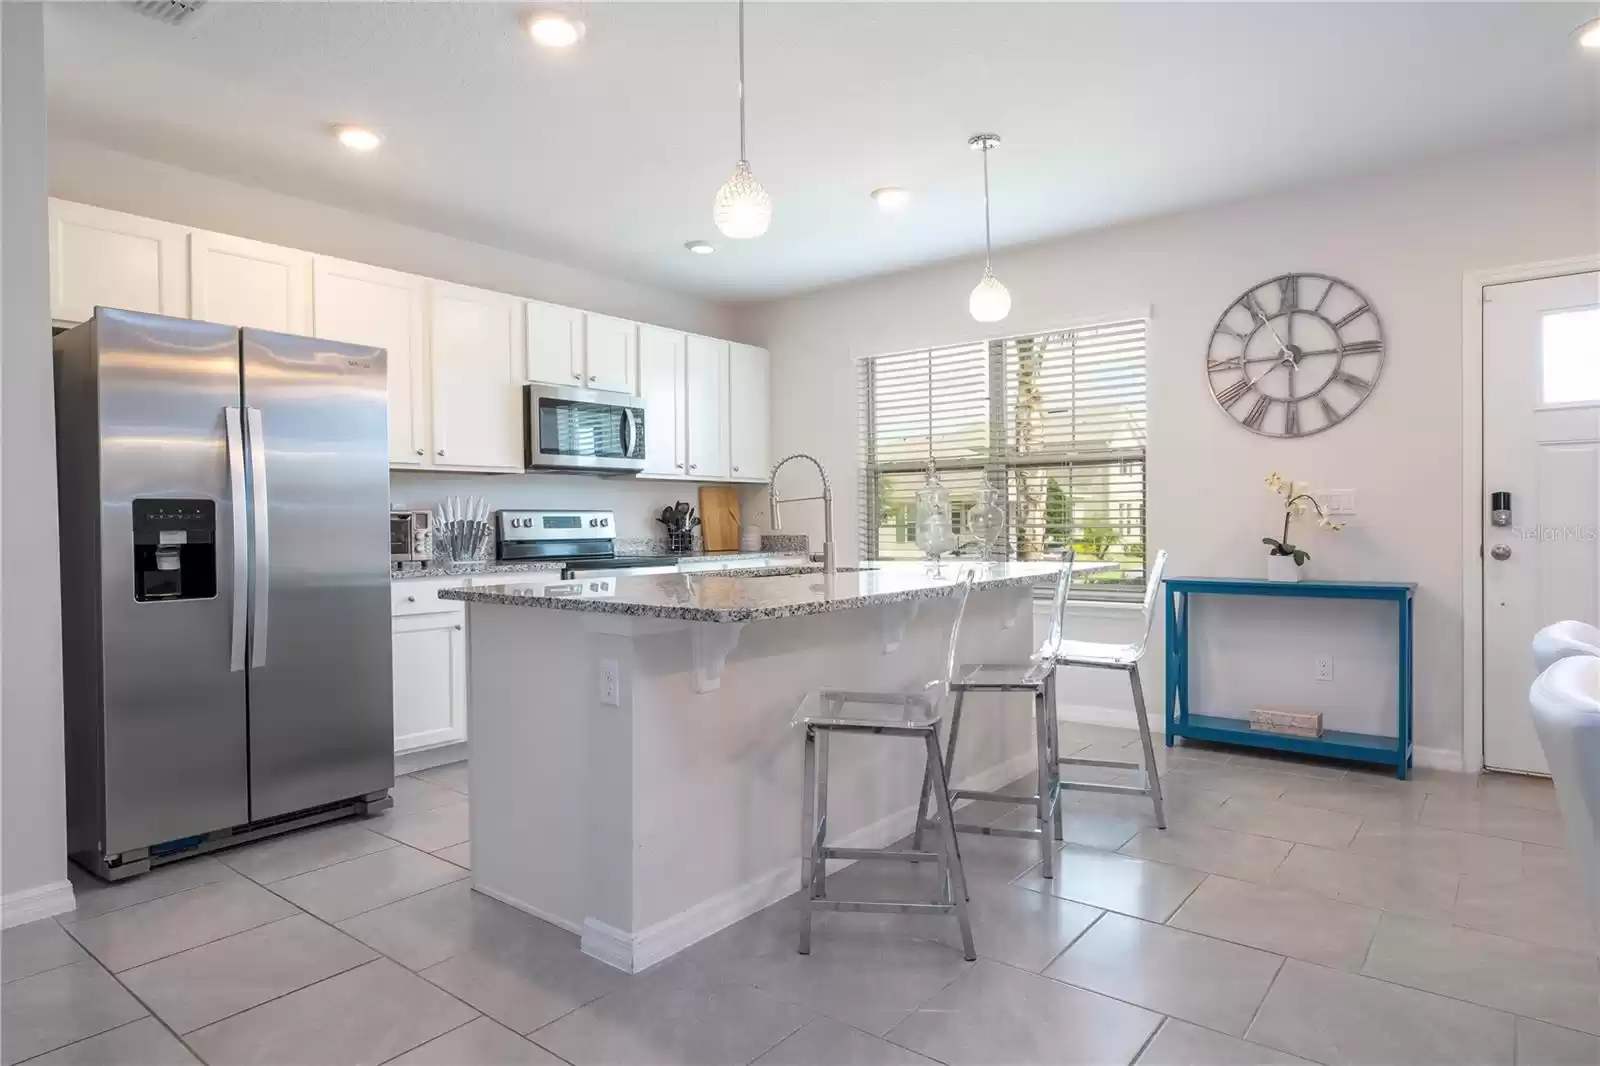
xmin=1467 ymin=272 xmax=1600 ymax=773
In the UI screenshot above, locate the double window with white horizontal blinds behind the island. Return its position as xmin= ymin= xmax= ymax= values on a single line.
xmin=861 ymin=320 xmax=1146 ymax=600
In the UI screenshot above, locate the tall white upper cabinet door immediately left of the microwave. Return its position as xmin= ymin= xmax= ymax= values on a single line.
xmin=427 ymin=282 xmax=523 ymax=471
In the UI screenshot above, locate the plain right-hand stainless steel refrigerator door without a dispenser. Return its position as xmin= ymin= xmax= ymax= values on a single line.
xmin=242 ymin=330 xmax=394 ymax=821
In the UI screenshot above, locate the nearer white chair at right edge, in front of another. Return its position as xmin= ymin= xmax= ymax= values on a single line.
xmin=1528 ymin=655 xmax=1600 ymax=933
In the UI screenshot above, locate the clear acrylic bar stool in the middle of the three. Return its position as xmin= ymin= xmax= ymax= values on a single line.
xmin=912 ymin=549 xmax=1074 ymax=877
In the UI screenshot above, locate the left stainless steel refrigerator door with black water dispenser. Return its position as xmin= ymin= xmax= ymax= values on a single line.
xmin=91 ymin=309 xmax=250 ymax=853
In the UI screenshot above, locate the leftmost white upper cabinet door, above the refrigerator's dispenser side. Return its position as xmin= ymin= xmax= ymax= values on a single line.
xmin=50 ymin=200 xmax=189 ymax=323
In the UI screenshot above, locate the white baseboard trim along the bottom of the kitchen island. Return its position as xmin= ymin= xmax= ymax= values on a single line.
xmin=576 ymin=752 xmax=1037 ymax=973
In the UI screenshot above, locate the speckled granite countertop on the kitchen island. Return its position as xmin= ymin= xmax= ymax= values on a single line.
xmin=438 ymin=560 xmax=1115 ymax=623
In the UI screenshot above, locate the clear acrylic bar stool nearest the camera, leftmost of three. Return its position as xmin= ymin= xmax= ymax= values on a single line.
xmin=794 ymin=570 xmax=978 ymax=962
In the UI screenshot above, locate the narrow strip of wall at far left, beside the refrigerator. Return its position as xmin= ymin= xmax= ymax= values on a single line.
xmin=0 ymin=3 xmax=72 ymax=925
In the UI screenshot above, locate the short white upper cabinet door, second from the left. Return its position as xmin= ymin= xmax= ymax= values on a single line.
xmin=189 ymin=230 xmax=312 ymax=335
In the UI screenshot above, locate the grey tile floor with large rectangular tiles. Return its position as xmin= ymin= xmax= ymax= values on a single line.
xmin=0 ymin=725 xmax=1600 ymax=1066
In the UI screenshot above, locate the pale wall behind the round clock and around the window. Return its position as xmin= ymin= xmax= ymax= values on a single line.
xmin=741 ymin=134 xmax=1600 ymax=760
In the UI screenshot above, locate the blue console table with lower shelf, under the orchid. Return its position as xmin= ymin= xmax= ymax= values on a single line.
xmin=1163 ymin=578 xmax=1416 ymax=779
